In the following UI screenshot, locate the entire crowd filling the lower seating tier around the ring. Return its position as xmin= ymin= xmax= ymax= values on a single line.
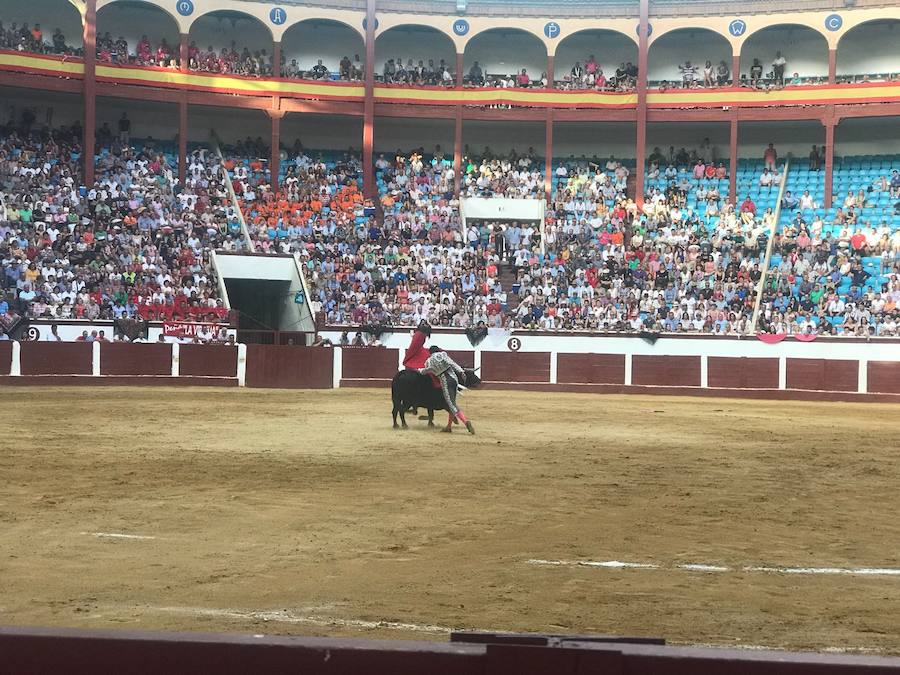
xmin=0 ymin=111 xmax=900 ymax=336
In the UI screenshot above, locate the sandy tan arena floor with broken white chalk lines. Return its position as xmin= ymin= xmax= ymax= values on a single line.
xmin=0 ymin=387 xmax=900 ymax=653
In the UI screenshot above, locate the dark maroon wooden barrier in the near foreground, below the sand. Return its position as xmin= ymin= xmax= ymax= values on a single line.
xmin=0 ymin=627 xmax=900 ymax=675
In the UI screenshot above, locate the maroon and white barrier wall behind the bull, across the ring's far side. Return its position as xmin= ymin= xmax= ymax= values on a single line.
xmin=0 ymin=333 xmax=900 ymax=402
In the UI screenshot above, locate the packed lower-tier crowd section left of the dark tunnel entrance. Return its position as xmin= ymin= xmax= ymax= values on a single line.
xmin=0 ymin=116 xmax=239 ymax=332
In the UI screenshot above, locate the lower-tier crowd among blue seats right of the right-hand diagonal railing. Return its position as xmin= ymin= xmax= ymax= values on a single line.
xmin=759 ymin=160 xmax=900 ymax=337
